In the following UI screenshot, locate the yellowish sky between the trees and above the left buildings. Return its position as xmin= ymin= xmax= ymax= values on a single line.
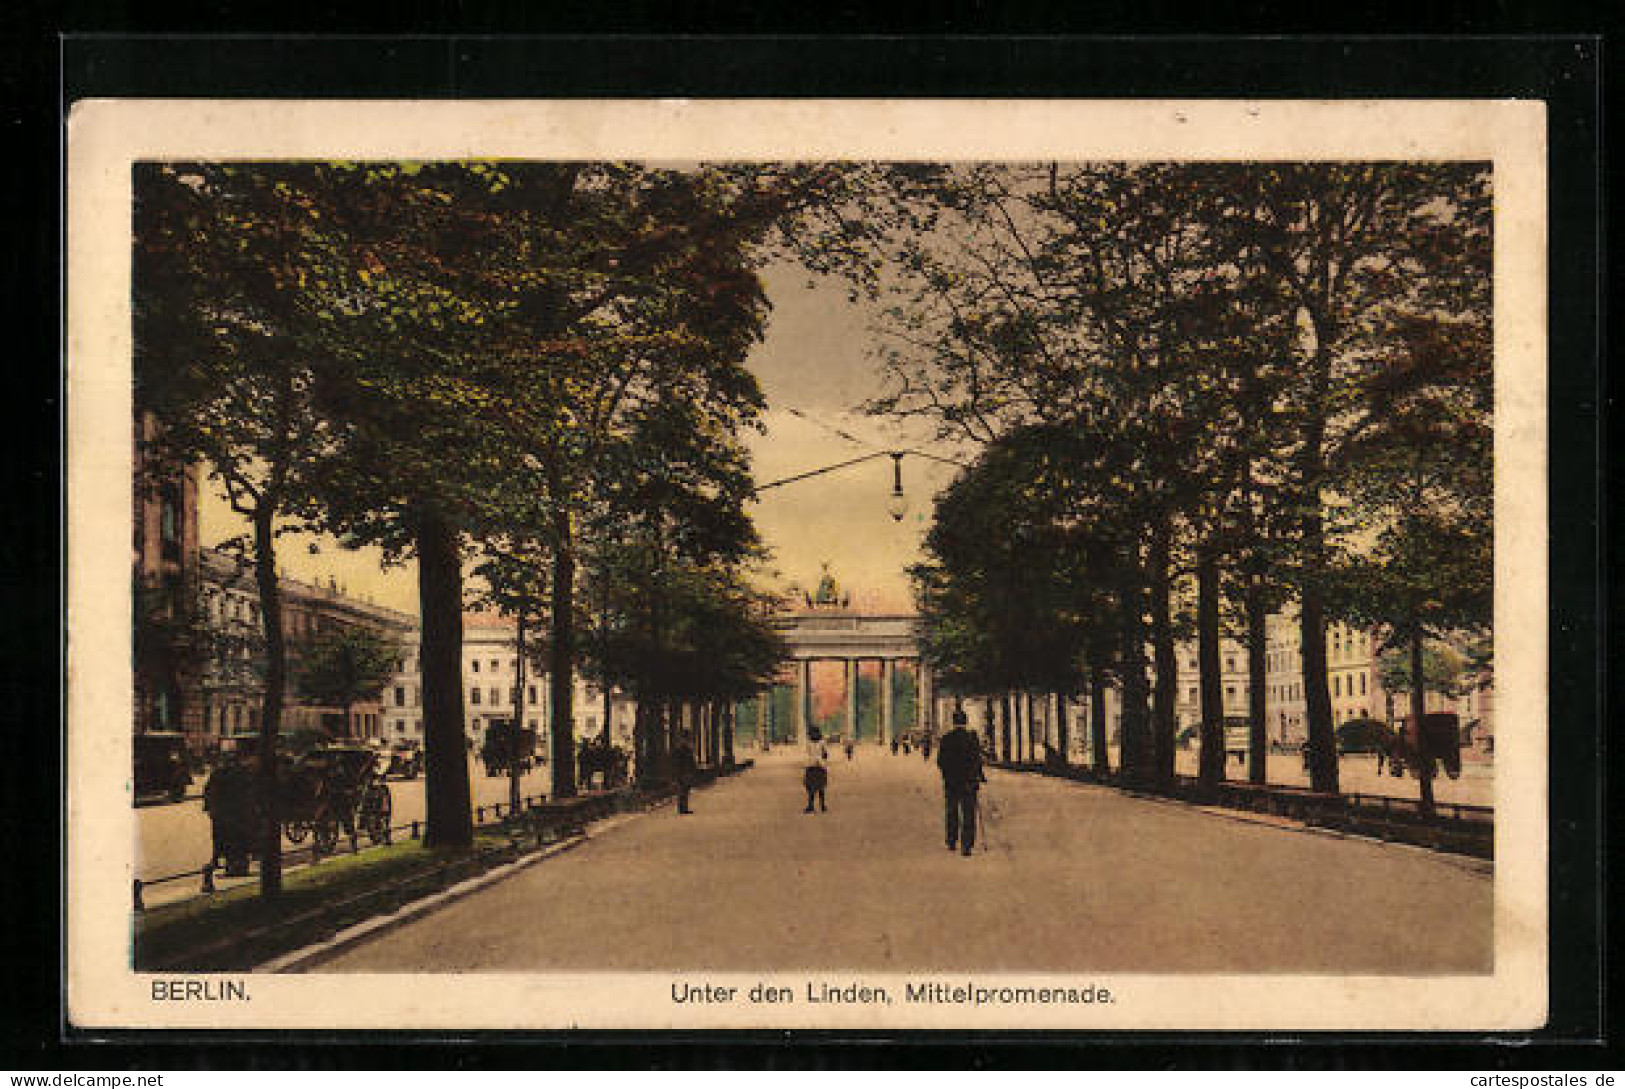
xmin=200 ymin=267 xmax=956 ymax=624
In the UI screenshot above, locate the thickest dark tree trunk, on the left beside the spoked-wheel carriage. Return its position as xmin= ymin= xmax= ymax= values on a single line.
xmin=418 ymin=514 xmax=475 ymax=847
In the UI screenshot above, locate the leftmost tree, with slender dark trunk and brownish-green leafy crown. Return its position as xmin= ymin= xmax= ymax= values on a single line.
xmin=133 ymin=163 xmax=342 ymax=897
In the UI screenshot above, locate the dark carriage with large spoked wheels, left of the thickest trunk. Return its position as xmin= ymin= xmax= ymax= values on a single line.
xmin=276 ymin=744 xmax=392 ymax=850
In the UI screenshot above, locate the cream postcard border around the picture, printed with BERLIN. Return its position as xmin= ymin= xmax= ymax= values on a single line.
xmin=65 ymin=99 xmax=1549 ymax=1032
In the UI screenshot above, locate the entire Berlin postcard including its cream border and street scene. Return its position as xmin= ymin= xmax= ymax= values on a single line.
xmin=67 ymin=102 xmax=1545 ymax=1029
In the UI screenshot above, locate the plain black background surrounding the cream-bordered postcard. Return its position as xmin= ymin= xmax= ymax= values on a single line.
xmin=12 ymin=32 xmax=1619 ymax=1069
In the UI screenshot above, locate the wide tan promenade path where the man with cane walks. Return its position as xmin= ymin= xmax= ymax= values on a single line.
xmin=314 ymin=748 xmax=1492 ymax=975
